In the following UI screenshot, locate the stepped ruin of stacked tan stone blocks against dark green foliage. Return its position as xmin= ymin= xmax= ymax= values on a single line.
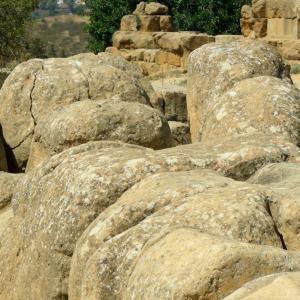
xmin=107 ymin=2 xmax=215 ymax=75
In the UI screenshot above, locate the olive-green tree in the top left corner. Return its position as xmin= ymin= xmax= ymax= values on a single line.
xmin=0 ymin=0 xmax=37 ymax=65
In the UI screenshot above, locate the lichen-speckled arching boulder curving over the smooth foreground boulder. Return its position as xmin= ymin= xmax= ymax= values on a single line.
xmin=69 ymin=170 xmax=282 ymax=299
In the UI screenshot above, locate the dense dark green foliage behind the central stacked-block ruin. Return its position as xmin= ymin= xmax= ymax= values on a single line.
xmin=87 ymin=0 xmax=251 ymax=52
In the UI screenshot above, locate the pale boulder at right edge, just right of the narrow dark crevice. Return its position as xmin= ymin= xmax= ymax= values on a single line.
xmin=249 ymin=163 xmax=300 ymax=251
